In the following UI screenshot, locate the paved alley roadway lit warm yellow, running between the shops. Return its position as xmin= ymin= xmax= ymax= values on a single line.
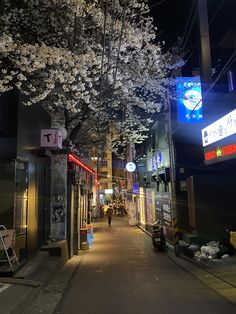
xmin=54 ymin=217 xmax=236 ymax=314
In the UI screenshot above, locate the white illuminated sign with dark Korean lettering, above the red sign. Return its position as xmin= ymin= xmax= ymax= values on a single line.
xmin=202 ymin=109 xmax=236 ymax=147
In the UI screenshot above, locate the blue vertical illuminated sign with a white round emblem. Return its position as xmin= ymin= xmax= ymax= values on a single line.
xmin=176 ymin=77 xmax=203 ymax=123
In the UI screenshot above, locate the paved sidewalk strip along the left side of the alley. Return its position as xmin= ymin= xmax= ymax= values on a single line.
xmin=0 ymin=245 xmax=84 ymax=314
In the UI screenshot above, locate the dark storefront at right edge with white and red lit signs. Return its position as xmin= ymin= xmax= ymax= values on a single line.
xmin=187 ymin=110 xmax=236 ymax=240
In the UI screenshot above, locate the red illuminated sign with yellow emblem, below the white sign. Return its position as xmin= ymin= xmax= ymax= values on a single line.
xmin=204 ymin=144 xmax=236 ymax=161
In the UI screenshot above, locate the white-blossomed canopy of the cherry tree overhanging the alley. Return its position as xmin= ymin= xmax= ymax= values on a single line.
xmin=0 ymin=0 xmax=183 ymax=156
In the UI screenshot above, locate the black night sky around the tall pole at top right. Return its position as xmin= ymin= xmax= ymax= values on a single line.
xmin=149 ymin=0 xmax=236 ymax=76
